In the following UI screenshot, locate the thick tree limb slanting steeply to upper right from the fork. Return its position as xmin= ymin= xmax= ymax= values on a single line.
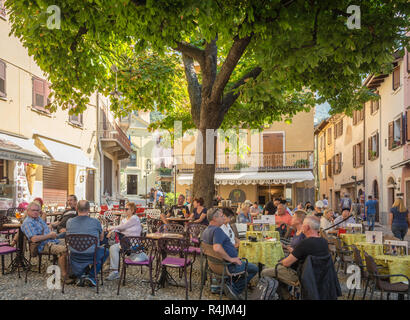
xmin=211 ymin=34 xmax=252 ymax=103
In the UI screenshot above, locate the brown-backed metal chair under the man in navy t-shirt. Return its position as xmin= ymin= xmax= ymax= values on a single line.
xmin=199 ymin=241 xmax=248 ymax=300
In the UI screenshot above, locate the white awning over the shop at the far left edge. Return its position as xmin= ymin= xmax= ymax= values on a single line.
xmin=0 ymin=133 xmax=51 ymax=166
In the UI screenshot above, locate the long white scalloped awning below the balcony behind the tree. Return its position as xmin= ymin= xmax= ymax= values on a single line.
xmin=177 ymin=171 xmax=314 ymax=185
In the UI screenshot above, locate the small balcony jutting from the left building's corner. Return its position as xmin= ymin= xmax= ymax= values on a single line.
xmin=100 ymin=121 xmax=131 ymax=160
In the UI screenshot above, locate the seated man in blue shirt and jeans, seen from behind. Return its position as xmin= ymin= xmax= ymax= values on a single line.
xmin=67 ymin=200 xmax=109 ymax=286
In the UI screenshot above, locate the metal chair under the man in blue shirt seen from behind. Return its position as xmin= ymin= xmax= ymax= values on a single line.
xmin=61 ymin=234 xmax=105 ymax=294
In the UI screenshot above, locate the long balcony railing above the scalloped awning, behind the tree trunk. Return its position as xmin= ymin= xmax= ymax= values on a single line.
xmin=177 ymin=151 xmax=313 ymax=173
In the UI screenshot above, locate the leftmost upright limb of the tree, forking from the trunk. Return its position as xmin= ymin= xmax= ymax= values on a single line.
xmin=182 ymin=53 xmax=201 ymax=128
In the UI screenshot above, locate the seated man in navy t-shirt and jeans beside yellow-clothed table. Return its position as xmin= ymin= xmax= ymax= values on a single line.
xmin=201 ymin=208 xmax=258 ymax=300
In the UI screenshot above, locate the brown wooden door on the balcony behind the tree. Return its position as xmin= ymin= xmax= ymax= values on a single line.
xmin=261 ymin=133 xmax=283 ymax=169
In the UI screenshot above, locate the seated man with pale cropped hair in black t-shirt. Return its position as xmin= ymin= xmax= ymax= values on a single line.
xmin=261 ymin=216 xmax=329 ymax=300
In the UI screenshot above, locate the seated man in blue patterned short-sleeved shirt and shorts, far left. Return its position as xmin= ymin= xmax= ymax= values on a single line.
xmin=21 ymin=201 xmax=69 ymax=284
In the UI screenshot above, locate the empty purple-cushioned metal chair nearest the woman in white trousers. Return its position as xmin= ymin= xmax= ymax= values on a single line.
xmin=117 ymin=237 xmax=158 ymax=295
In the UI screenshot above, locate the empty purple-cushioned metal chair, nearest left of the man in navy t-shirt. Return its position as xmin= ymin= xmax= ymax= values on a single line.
xmin=156 ymin=238 xmax=193 ymax=300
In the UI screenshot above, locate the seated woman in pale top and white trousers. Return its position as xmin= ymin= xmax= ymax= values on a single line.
xmin=107 ymin=202 xmax=148 ymax=280
